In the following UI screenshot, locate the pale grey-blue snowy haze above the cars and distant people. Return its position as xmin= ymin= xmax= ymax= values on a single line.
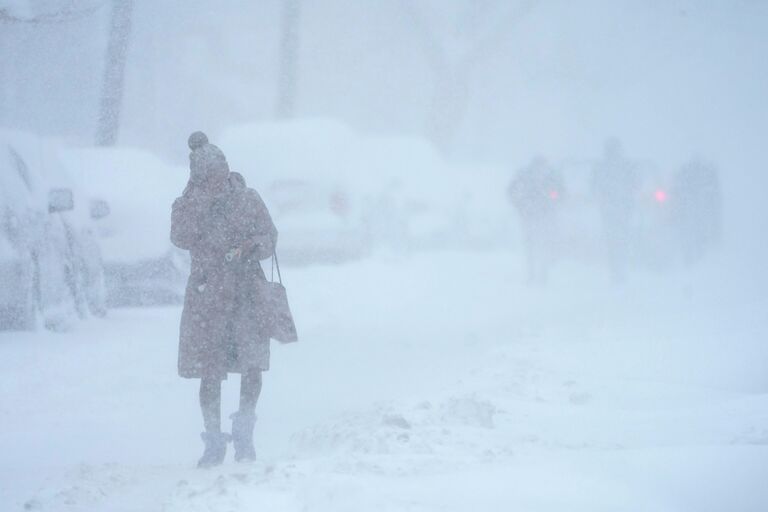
xmin=0 ymin=0 xmax=768 ymax=258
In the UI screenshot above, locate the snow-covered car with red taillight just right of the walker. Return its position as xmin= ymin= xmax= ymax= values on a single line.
xmin=220 ymin=121 xmax=369 ymax=264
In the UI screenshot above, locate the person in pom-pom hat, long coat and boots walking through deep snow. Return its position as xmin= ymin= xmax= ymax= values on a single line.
xmin=171 ymin=132 xmax=277 ymax=467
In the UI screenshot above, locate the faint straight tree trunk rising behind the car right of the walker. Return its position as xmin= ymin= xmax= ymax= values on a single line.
xmin=275 ymin=0 xmax=301 ymax=119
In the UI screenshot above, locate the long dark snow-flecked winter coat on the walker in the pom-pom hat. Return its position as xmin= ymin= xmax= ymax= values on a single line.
xmin=171 ymin=173 xmax=277 ymax=379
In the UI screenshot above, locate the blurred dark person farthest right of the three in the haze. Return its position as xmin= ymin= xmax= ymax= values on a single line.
xmin=671 ymin=160 xmax=721 ymax=265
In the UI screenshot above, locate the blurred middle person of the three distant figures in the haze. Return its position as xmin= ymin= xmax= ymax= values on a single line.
xmin=592 ymin=138 xmax=640 ymax=283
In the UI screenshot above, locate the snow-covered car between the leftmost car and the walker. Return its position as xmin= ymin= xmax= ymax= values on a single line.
xmin=62 ymin=148 xmax=189 ymax=307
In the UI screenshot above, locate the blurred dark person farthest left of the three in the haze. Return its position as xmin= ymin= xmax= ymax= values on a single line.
xmin=508 ymin=157 xmax=563 ymax=284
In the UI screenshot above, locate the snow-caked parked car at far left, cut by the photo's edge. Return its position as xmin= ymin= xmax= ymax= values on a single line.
xmin=0 ymin=131 xmax=106 ymax=330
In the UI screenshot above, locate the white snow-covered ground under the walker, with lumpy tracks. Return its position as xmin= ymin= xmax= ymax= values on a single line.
xmin=0 ymin=252 xmax=768 ymax=512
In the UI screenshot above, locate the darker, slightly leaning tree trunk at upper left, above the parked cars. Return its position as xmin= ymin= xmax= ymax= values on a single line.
xmin=96 ymin=0 xmax=133 ymax=146
